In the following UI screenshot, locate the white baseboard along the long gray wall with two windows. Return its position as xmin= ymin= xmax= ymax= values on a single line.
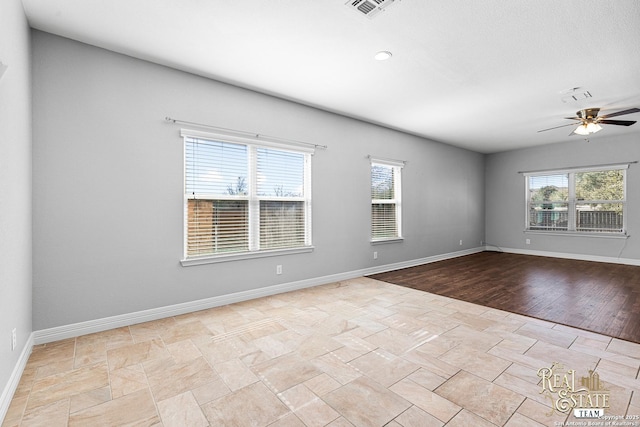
xmin=33 ymin=248 xmax=484 ymax=344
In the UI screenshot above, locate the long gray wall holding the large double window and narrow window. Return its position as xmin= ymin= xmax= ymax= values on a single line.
xmin=32 ymin=31 xmax=484 ymax=330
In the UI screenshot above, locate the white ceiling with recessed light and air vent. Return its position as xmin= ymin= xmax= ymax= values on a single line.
xmin=22 ymin=0 xmax=640 ymax=153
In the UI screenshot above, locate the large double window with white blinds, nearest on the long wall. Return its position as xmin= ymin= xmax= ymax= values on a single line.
xmin=183 ymin=132 xmax=311 ymax=259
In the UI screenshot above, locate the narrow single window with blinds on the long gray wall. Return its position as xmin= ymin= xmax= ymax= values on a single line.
xmin=371 ymin=159 xmax=404 ymax=241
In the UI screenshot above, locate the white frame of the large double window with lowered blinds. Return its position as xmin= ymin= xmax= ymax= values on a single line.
xmin=180 ymin=129 xmax=315 ymax=267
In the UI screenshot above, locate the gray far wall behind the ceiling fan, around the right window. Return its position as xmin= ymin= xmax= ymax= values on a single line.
xmin=485 ymin=134 xmax=640 ymax=260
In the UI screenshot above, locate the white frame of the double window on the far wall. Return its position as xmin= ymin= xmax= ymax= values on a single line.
xmin=522 ymin=164 xmax=629 ymax=238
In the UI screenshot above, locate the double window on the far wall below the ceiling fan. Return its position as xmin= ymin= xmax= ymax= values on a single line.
xmin=525 ymin=165 xmax=627 ymax=233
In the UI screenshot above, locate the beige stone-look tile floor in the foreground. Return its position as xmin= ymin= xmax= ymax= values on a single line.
xmin=2 ymin=278 xmax=640 ymax=427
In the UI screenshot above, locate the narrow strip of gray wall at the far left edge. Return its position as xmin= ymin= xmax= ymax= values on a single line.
xmin=0 ymin=0 xmax=31 ymax=408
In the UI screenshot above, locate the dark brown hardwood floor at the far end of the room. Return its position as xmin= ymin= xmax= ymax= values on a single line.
xmin=369 ymin=252 xmax=640 ymax=343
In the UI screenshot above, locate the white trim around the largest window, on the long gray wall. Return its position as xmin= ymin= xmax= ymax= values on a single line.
xmin=180 ymin=129 xmax=315 ymax=267
